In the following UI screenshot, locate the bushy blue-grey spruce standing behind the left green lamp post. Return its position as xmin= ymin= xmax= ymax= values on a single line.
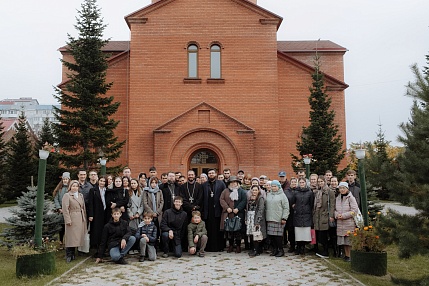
xmin=1 ymin=187 xmax=61 ymax=245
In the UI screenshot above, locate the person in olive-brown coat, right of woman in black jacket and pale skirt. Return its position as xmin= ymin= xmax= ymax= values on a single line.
xmin=313 ymin=176 xmax=335 ymax=258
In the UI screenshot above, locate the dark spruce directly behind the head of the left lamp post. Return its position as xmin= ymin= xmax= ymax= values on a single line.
xmin=34 ymin=117 xmax=63 ymax=195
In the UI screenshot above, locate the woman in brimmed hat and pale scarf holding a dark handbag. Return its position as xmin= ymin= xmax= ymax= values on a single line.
xmin=220 ymin=176 xmax=247 ymax=253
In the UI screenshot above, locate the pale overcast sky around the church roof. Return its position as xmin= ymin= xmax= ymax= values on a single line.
xmin=0 ymin=0 xmax=429 ymax=145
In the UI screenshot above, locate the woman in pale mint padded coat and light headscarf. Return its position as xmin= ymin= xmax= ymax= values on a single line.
xmin=265 ymin=180 xmax=289 ymax=257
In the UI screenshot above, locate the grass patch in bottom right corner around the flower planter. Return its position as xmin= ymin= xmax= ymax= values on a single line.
xmin=329 ymin=245 xmax=429 ymax=286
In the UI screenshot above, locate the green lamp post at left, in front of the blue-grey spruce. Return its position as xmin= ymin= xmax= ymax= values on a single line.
xmin=34 ymin=150 xmax=49 ymax=247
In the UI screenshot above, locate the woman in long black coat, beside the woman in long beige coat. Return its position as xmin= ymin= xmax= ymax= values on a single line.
xmin=87 ymin=176 xmax=107 ymax=248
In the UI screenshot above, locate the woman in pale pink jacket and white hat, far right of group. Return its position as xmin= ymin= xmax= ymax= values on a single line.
xmin=335 ymin=182 xmax=359 ymax=262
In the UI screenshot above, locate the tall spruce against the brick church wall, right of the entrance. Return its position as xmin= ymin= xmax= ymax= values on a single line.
xmin=291 ymin=56 xmax=345 ymax=174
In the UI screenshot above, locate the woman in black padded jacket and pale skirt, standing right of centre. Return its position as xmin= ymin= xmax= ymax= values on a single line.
xmin=292 ymin=178 xmax=314 ymax=254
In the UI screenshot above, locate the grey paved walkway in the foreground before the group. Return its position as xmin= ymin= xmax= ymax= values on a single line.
xmin=51 ymin=252 xmax=363 ymax=286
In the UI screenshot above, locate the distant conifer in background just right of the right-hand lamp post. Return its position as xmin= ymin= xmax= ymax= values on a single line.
xmin=365 ymin=124 xmax=397 ymax=199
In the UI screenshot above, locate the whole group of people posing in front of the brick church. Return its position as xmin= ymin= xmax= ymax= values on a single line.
xmin=53 ymin=167 xmax=360 ymax=264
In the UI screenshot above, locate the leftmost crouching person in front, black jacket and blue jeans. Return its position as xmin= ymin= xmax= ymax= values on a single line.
xmin=95 ymin=208 xmax=136 ymax=264
